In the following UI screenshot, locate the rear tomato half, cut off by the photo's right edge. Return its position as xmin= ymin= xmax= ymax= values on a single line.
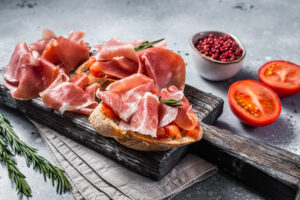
xmin=258 ymin=60 xmax=300 ymax=97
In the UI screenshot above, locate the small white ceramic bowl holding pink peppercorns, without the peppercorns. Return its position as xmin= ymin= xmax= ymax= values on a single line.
xmin=190 ymin=31 xmax=246 ymax=81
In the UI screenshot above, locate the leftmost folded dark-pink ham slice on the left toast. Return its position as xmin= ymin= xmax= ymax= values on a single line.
xmin=3 ymin=42 xmax=59 ymax=100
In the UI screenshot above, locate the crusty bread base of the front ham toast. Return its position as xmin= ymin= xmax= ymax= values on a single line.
xmin=89 ymin=103 xmax=203 ymax=151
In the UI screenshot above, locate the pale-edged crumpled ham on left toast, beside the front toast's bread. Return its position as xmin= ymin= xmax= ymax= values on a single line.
xmin=40 ymin=71 xmax=99 ymax=115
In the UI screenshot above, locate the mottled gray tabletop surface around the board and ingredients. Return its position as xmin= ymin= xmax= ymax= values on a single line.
xmin=0 ymin=0 xmax=300 ymax=200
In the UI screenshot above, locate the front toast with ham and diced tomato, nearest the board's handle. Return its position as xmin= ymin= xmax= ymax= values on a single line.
xmin=89 ymin=74 xmax=203 ymax=151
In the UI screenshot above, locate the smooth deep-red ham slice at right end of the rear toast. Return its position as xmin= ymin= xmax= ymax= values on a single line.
xmin=138 ymin=47 xmax=185 ymax=90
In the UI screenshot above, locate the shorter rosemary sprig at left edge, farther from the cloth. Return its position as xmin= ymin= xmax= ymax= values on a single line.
xmin=0 ymin=137 xmax=31 ymax=197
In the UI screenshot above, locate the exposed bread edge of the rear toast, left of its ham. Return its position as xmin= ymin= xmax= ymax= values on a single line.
xmin=75 ymin=61 xmax=116 ymax=90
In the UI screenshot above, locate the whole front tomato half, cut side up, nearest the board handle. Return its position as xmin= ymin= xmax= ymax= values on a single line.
xmin=228 ymin=80 xmax=281 ymax=126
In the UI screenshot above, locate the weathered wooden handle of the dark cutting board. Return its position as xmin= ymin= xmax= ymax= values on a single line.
xmin=192 ymin=123 xmax=300 ymax=200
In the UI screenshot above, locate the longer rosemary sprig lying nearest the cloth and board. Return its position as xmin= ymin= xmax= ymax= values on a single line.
xmin=0 ymin=113 xmax=71 ymax=197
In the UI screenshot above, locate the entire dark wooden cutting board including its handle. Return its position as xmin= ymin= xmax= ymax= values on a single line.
xmin=0 ymin=74 xmax=300 ymax=200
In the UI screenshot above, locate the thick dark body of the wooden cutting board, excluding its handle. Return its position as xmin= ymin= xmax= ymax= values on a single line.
xmin=0 ymin=77 xmax=223 ymax=180
